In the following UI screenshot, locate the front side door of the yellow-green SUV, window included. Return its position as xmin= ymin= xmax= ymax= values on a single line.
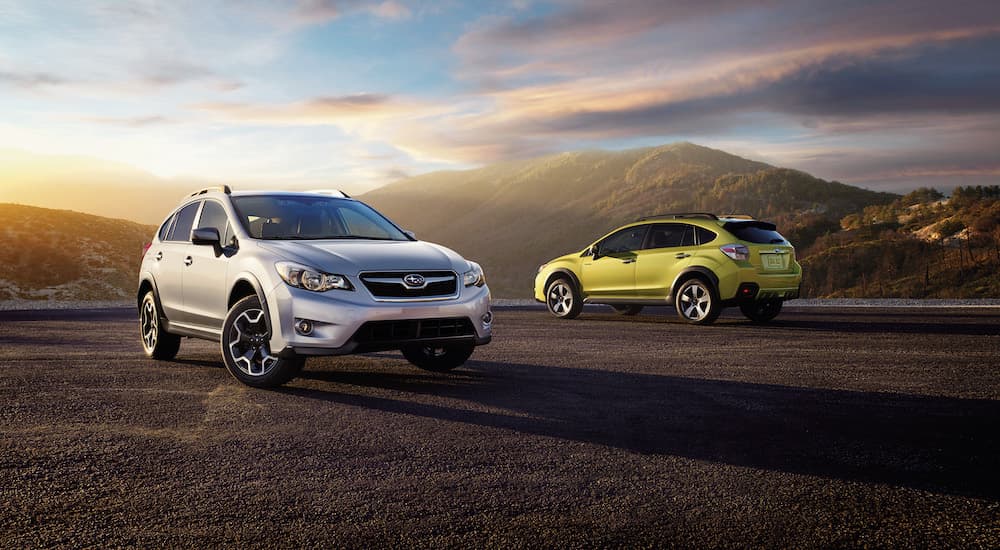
xmin=580 ymin=225 xmax=649 ymax=298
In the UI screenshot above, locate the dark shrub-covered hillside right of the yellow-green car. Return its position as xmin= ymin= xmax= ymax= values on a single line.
xmin=800 ymin=186 xmax=1000 ymax=298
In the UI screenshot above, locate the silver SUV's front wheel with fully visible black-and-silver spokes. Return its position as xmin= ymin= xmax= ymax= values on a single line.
xmin=222 ymin=296 xmax=305 ymax=388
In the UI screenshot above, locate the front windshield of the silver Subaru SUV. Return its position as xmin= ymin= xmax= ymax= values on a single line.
xmin=233 ymin=195 xmax=411 ymax=241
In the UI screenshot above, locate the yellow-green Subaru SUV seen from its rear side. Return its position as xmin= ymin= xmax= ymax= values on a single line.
xmin=534 ymin=213 xmax=802 ymax=324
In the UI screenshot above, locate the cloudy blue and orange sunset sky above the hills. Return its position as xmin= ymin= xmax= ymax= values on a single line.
xmin=0 ymin=0 xmax=1000 ymax=196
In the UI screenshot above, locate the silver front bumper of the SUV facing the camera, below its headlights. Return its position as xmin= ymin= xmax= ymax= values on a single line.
xmin=265 ymin=283 xmax=493 ymax=357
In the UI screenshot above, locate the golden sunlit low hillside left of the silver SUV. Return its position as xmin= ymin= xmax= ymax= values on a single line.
xmin=0 ymin=204 xmax=156 ymax=301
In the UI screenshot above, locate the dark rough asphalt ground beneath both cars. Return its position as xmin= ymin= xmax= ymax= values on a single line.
xmin=0 ymin=308 xmax=1000 ymax=548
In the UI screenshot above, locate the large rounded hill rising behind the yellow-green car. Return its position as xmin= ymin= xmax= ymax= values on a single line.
xmin=361 ymin=143 xmax=898 ymax=298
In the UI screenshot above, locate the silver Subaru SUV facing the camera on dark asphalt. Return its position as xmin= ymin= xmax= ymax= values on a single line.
xmin=137 ymin=186 xmax=493 ymax=387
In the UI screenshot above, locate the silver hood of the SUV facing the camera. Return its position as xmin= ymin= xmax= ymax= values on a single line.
xmin=250 ymin=240 xmax=469 ymax=276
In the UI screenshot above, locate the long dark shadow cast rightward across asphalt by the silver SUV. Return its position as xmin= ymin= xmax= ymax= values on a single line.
xmin=286 ymin=361 xmax=1000 ymax=501
